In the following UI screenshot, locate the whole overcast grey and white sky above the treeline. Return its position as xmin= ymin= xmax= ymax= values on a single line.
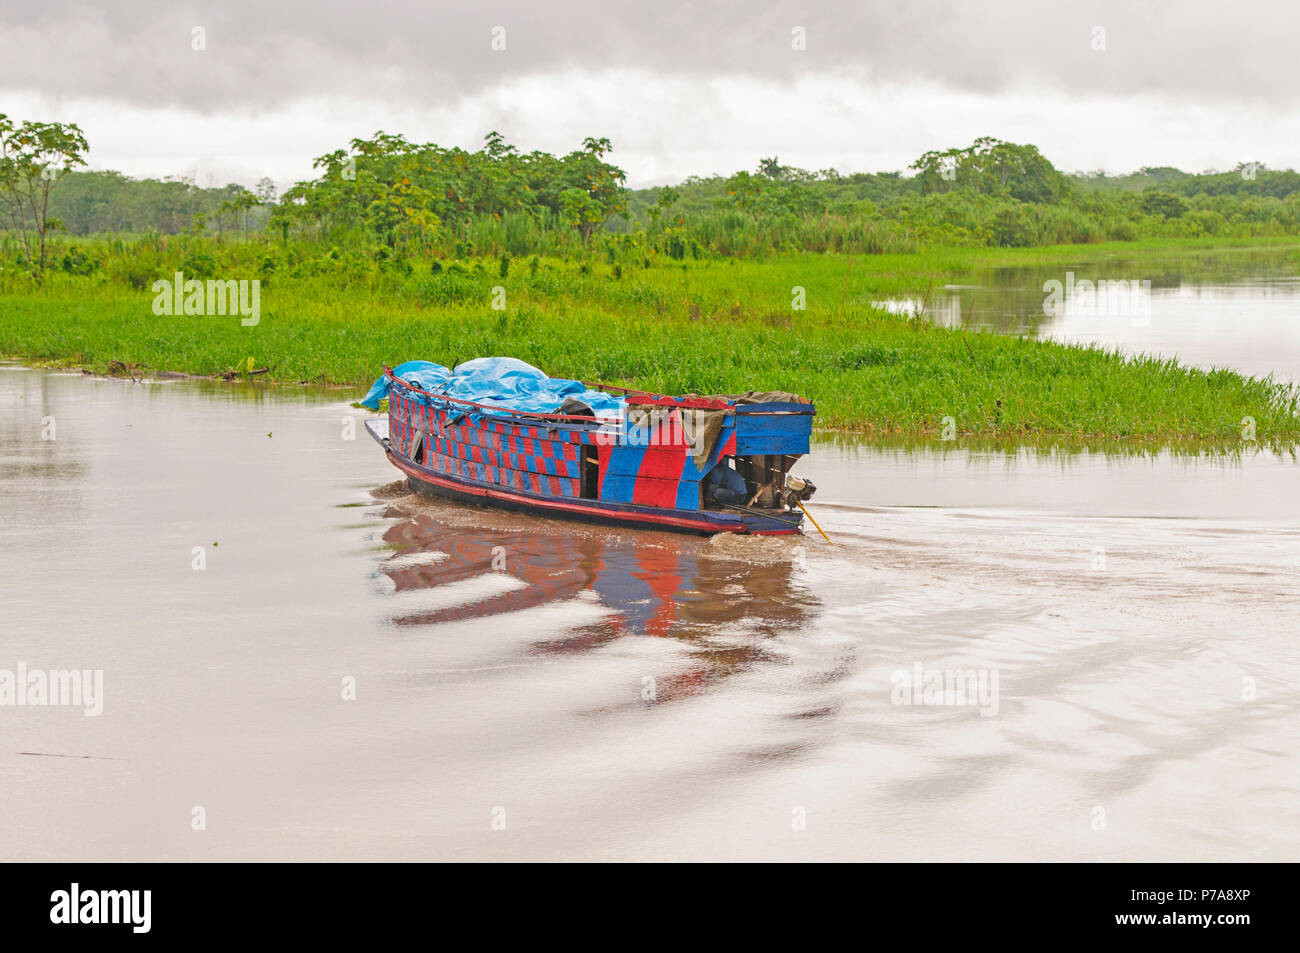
xmin=0 ymin=0 xmax=1300 ymax=187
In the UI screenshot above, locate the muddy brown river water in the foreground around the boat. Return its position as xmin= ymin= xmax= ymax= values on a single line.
xmin=0 ymin=367 xmax=1300 ymax=861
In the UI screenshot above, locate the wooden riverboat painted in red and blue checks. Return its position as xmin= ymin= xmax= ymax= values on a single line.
xmin=365 ymin=367 xmax=815 ymax=536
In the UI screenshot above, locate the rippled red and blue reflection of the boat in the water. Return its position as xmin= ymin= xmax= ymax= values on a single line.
xmin=378 ymin=497 xmax=820 ymax=699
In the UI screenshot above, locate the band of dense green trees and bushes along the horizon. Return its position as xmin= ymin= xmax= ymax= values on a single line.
xmin=0 ymin=117 xmax=1300 ymax=280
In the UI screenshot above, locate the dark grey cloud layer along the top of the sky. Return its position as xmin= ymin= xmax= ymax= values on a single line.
xmin=0 ymin=0 xmax=1297 ymax=112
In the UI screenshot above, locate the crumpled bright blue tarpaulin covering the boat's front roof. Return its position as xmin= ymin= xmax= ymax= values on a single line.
xmin=361 ymin=358 xmax=624 ymax=417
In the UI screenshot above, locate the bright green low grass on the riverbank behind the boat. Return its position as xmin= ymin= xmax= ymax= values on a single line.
xmin=0 ymin=239 xmax=1300 ymax=445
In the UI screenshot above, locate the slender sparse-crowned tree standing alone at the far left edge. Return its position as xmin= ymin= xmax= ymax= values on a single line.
xmin=0 ymin=113 xmax=90 ymax=278
